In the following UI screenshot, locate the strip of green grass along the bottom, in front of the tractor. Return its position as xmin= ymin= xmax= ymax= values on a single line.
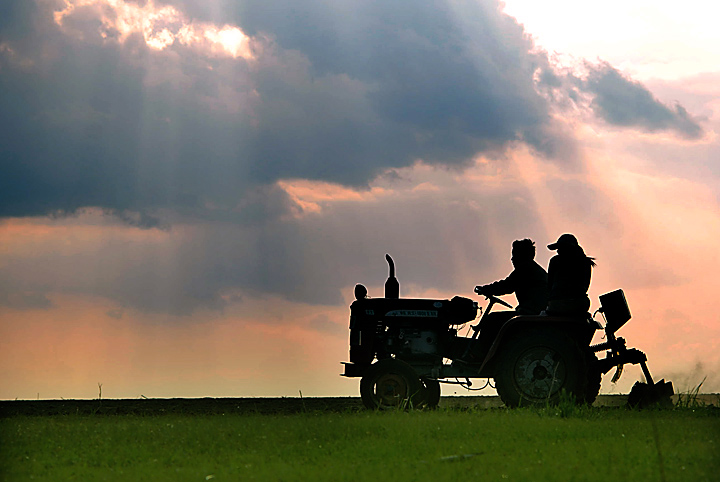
xmin=0 ymin=407 xmax=720 ymax=481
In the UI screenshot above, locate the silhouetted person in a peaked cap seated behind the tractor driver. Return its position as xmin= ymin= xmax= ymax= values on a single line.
xmin=546 ymin=234 xmax=595 ymax=315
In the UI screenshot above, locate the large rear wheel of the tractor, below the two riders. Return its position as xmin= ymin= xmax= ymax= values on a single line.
xmin=495 ymin=330 xmax=588 ymax=407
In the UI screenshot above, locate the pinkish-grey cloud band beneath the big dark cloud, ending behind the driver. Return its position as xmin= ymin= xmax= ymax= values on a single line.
xmin=0 ymin=161 xmax=542 ymax=315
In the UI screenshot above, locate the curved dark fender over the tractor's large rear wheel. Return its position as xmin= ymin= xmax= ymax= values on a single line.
xmin=478 ymin=315 xmax=597 ymax=378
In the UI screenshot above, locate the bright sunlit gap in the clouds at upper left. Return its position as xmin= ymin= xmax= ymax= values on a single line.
xmin=54 ymin=0 xmax=253 ymax=59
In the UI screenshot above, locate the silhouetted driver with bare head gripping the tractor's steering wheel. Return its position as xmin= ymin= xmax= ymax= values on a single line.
xmin=475 ymin=238 xmax=549 ymax=339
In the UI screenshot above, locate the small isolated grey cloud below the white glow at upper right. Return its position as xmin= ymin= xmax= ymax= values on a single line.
xmin=582 ymin=63 xmax=703 ymax=139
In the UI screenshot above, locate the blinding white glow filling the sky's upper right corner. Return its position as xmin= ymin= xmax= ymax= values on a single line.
xmin=503 ymin=0 xmax=720 ymax=80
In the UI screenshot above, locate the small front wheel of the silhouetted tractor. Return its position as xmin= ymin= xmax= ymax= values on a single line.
xmin=360 ymin=358 xmax=424 ymax=410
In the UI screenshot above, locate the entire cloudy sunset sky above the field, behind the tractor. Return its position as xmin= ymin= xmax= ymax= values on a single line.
xmin=0 ymin=0 xmax=720 ymax=399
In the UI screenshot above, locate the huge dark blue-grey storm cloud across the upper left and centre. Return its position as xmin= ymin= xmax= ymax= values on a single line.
xmin=0 ymin=2 xmax=564 ymax=220
